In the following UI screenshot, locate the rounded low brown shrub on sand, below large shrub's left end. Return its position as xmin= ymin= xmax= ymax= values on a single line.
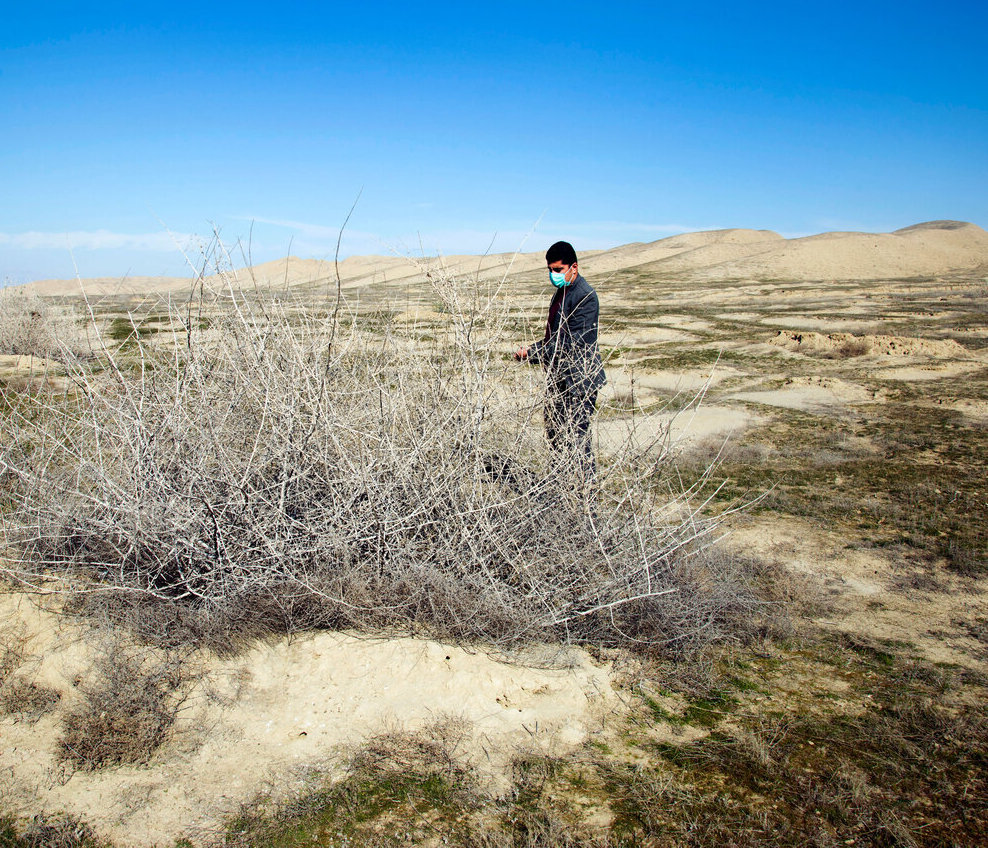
xmin=59 ymin=645 xmax=184 ymax=771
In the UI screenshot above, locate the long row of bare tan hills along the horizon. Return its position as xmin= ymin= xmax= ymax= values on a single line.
xmin=17 ymin=221 xmax=988 ymax=295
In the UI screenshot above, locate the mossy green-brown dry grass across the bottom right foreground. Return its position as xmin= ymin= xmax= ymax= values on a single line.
xmin=193 ymin=637 xmax=988 ymax=848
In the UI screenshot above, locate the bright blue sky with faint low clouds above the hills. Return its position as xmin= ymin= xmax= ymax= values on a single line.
xmin=0 ymin=0 xmax=988 ymax=282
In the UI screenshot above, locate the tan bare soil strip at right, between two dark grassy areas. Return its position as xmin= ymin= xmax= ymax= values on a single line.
xmin=727 ymin=516 xmax=988 ymax=673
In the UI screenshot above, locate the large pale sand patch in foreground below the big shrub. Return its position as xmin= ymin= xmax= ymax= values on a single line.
xmin=0 ymin=595 xmax=619 ymax=846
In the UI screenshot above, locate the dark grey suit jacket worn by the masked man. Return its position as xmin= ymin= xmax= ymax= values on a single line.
xmin=528 ymin=274 xmax=607 ymax=394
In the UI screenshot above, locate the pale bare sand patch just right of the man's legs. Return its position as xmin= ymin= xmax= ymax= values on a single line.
xmin=595 ymin=404 xmax=763 ymax=454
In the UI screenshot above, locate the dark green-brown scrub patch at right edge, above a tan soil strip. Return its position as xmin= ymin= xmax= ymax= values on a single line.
xmin=681 ymin=401 xmax=988 ymax=577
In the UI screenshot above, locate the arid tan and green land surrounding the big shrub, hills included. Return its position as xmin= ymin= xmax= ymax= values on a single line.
xmin=0 ymin=222 xmax=988 ymax=846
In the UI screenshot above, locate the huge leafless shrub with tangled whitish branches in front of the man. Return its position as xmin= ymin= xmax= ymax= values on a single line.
xmin=0 ymin=260 xmax=753 ymax=647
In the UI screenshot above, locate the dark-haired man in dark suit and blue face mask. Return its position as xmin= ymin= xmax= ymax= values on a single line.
xmin=515 ymin=241 xmax=607 ymax=483
